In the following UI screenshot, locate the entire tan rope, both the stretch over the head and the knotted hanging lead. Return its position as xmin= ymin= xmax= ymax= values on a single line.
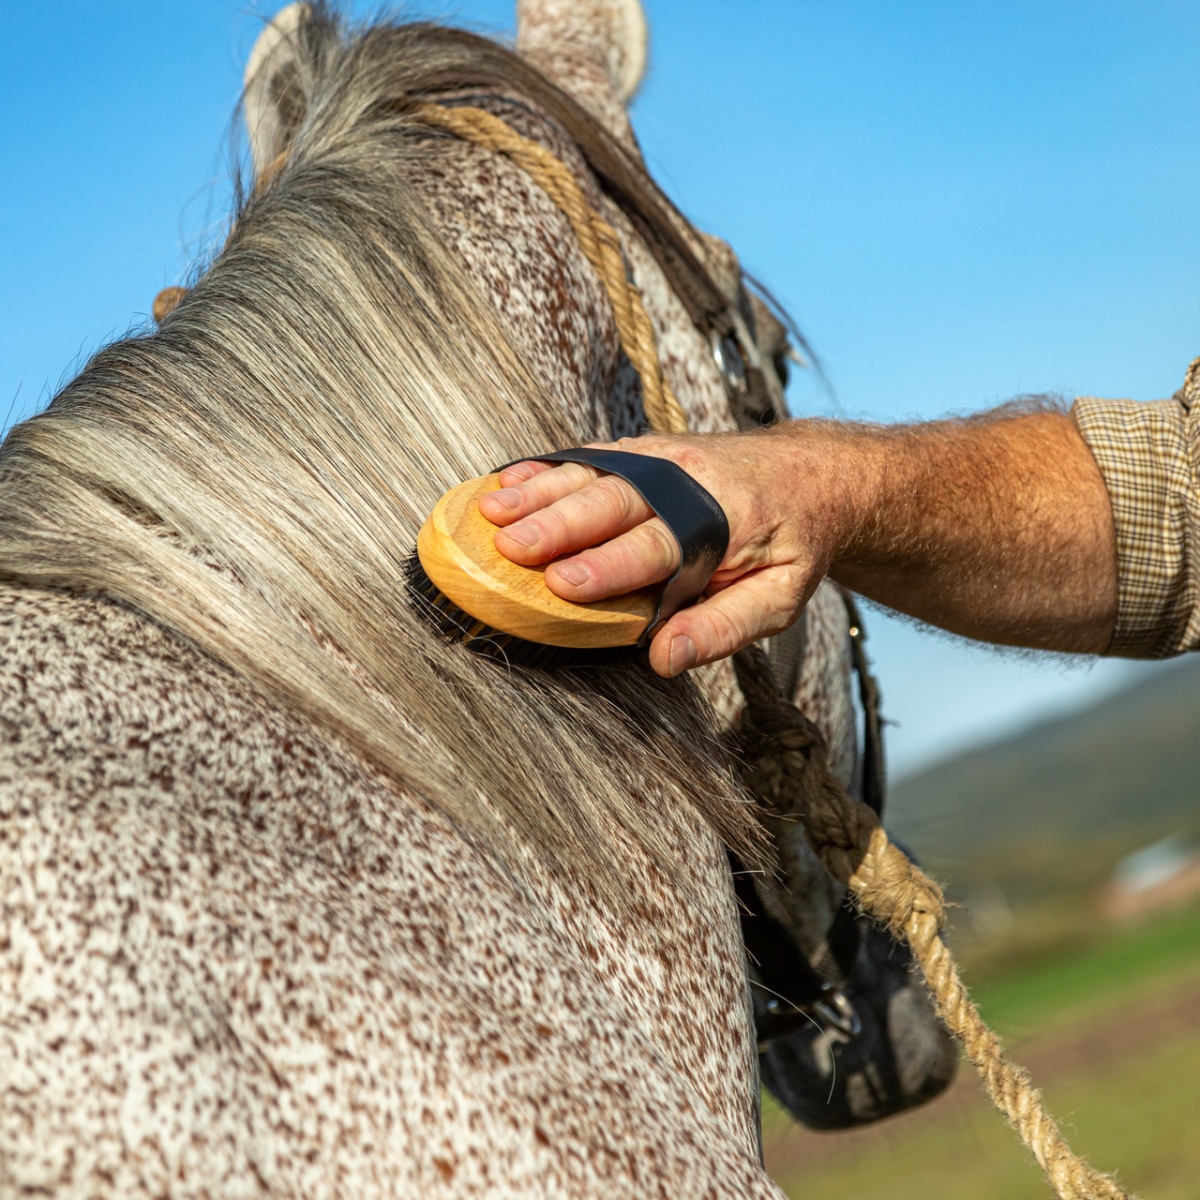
xmin=418 ymin=104 xmax=1130 ymax=1200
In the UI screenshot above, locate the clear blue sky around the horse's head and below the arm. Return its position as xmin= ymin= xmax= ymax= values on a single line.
xmin=0 ymin=0 xmax=1200 ymax=770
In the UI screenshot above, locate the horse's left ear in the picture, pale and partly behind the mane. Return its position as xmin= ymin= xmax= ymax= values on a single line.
xmin=242 ymin=0 xmax=312 ymax=178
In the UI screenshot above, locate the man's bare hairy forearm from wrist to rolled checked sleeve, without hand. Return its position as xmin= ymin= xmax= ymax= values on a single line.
xmin=794 ymin=412 xmax=1117 ymax=653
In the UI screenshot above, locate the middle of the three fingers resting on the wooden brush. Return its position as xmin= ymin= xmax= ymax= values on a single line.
xmin=485 ymin=472 xmax=654 ymax=566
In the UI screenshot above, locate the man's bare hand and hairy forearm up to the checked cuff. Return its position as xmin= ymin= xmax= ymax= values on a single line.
xmin=480 ymin=412 xmax=1117 ymax=676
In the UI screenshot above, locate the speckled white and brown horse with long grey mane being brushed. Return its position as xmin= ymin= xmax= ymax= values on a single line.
xmin=0 ymin=0 xmax=944 ymax=1196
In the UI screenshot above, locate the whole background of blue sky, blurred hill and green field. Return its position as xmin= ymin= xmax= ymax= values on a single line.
xmin=0 ymin=0 xmax=1200 ymax=1200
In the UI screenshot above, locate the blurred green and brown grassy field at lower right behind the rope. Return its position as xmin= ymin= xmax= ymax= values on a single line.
xmin=764 ymin=908 xmax=1200 ymax=1200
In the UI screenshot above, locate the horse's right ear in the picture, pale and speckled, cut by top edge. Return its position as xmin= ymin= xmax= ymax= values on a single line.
xmin=517 ymin=0 xmax=649 ymax=102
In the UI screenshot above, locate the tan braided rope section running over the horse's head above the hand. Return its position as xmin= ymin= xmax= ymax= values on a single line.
xmin=416 ymin=104 xmax=688 ymax=433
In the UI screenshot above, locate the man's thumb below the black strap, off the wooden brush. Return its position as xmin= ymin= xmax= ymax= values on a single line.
xmin=650 ymin=570 xmax=805 ymax=678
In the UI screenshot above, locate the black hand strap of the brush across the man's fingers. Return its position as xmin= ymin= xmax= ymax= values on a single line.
xmin=496 ymin=446 xmax=730 ymax=644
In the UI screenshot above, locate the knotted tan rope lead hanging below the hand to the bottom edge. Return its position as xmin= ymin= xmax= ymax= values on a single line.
xmin=734 ymin=647 xmax=1130 ymax=1200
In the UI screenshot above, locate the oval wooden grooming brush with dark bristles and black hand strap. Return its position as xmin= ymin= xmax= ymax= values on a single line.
xmin=408 ymin=449 xmax=730 ymax=666
